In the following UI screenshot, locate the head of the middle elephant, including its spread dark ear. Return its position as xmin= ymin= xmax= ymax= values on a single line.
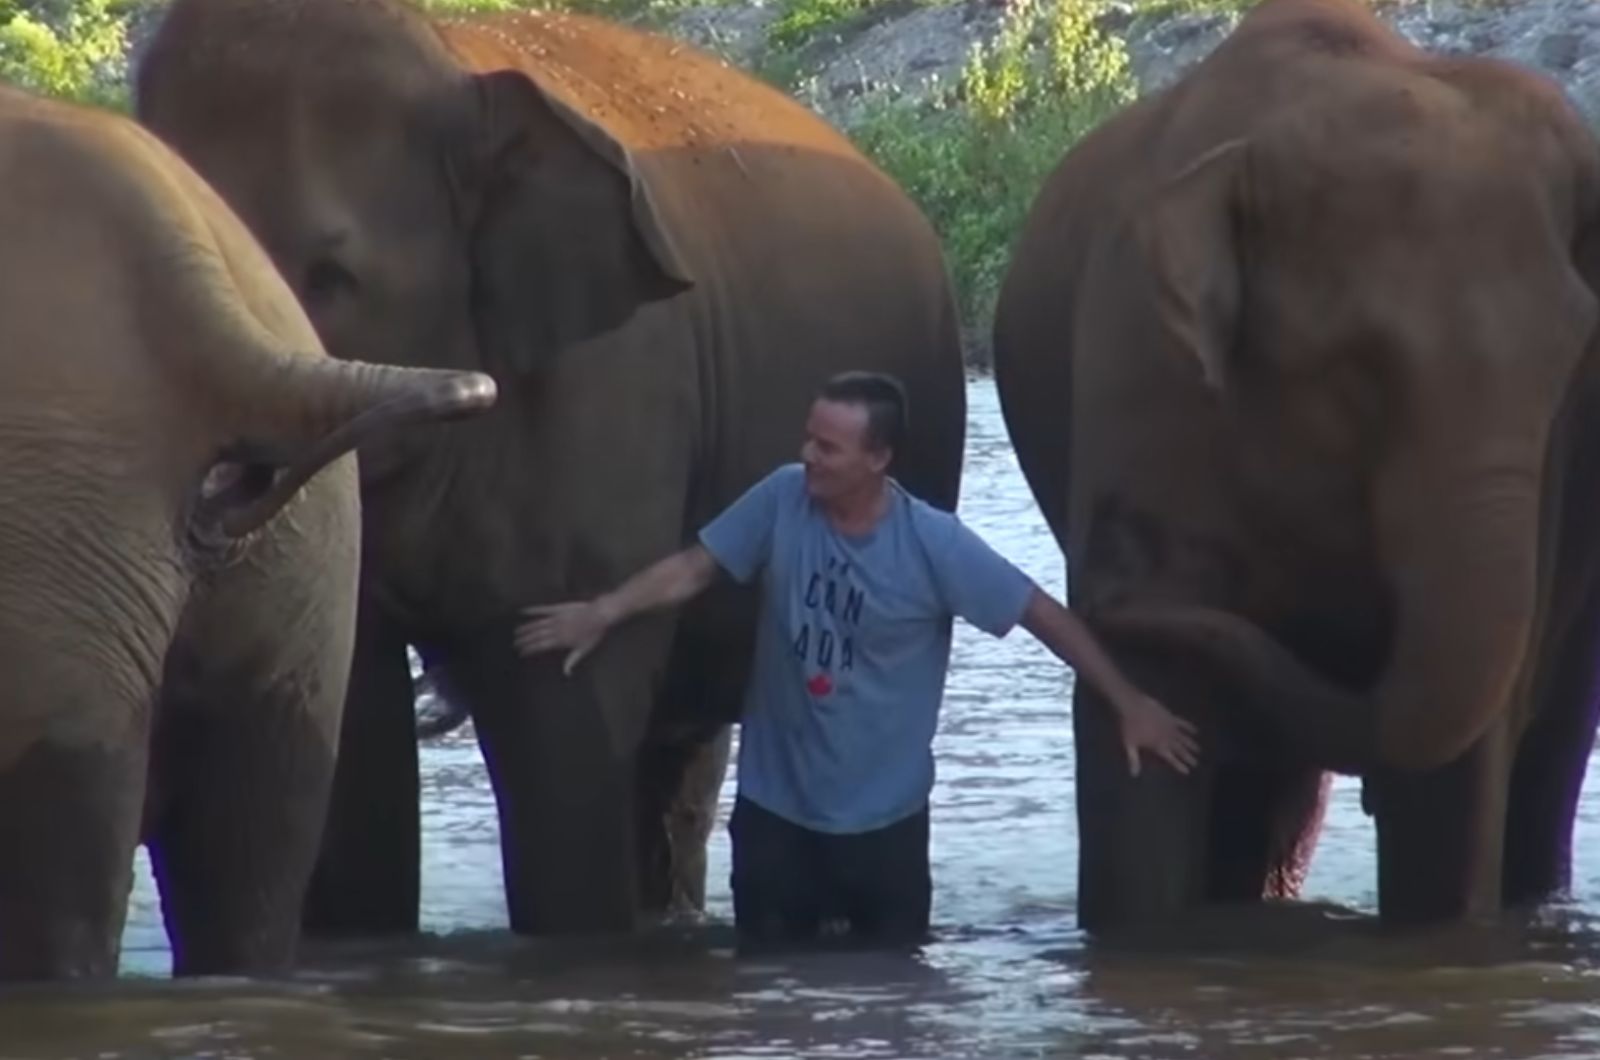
xmin=136 ymin=0 xmax=688 ymax=486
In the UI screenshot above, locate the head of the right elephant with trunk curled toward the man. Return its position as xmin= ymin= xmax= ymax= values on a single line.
xmin=1094 ymin=68 xmax=1597 ymax=772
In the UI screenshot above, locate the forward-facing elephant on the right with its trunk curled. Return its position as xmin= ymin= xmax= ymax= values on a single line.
xmin=994 ymin=0 xmax=1600 ymax=934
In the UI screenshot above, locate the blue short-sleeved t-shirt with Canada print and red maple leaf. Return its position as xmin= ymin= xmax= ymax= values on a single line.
xmin=699 ymin=464 xmax=1034 ymax=833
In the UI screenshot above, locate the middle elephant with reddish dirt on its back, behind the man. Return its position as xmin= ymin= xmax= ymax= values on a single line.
xmin=134 ymin=0 xmax=966 ymax=935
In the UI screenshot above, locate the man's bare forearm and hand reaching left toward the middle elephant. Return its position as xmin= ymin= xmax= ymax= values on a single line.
xmin=515 ymin=544 xmax=717 ymax=674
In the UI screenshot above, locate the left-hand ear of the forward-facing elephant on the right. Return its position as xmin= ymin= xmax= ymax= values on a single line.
xmin=1136 ymin=139 xmax=1246 ymax=389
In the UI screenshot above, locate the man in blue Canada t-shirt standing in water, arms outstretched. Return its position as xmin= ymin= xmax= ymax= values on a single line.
xmin=515 ymin=373 xmax=1198 ymax=946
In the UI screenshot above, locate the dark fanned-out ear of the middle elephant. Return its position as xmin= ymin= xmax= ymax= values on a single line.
xmin=469 ymin=70 xmax=693 ymax=373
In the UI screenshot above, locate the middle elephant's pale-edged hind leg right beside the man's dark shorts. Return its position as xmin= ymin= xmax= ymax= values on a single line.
xmin=635 ymin=725 xmax=733 ymax=914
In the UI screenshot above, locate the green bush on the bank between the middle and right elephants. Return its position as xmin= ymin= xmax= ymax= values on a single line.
xmin=854 ymin=0 xmax=1134 ymax=330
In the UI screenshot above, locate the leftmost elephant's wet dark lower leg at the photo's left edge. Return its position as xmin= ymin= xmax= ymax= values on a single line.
xmin=0 ymin=733 xmax=147 ymax=980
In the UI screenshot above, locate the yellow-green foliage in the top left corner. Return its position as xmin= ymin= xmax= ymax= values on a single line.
xmin=0 ymin=0 xmax=130 ymax=106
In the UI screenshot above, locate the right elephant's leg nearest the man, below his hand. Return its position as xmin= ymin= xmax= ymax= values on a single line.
xmin=1072 ymin=650 xmax=1214 ymax=934
